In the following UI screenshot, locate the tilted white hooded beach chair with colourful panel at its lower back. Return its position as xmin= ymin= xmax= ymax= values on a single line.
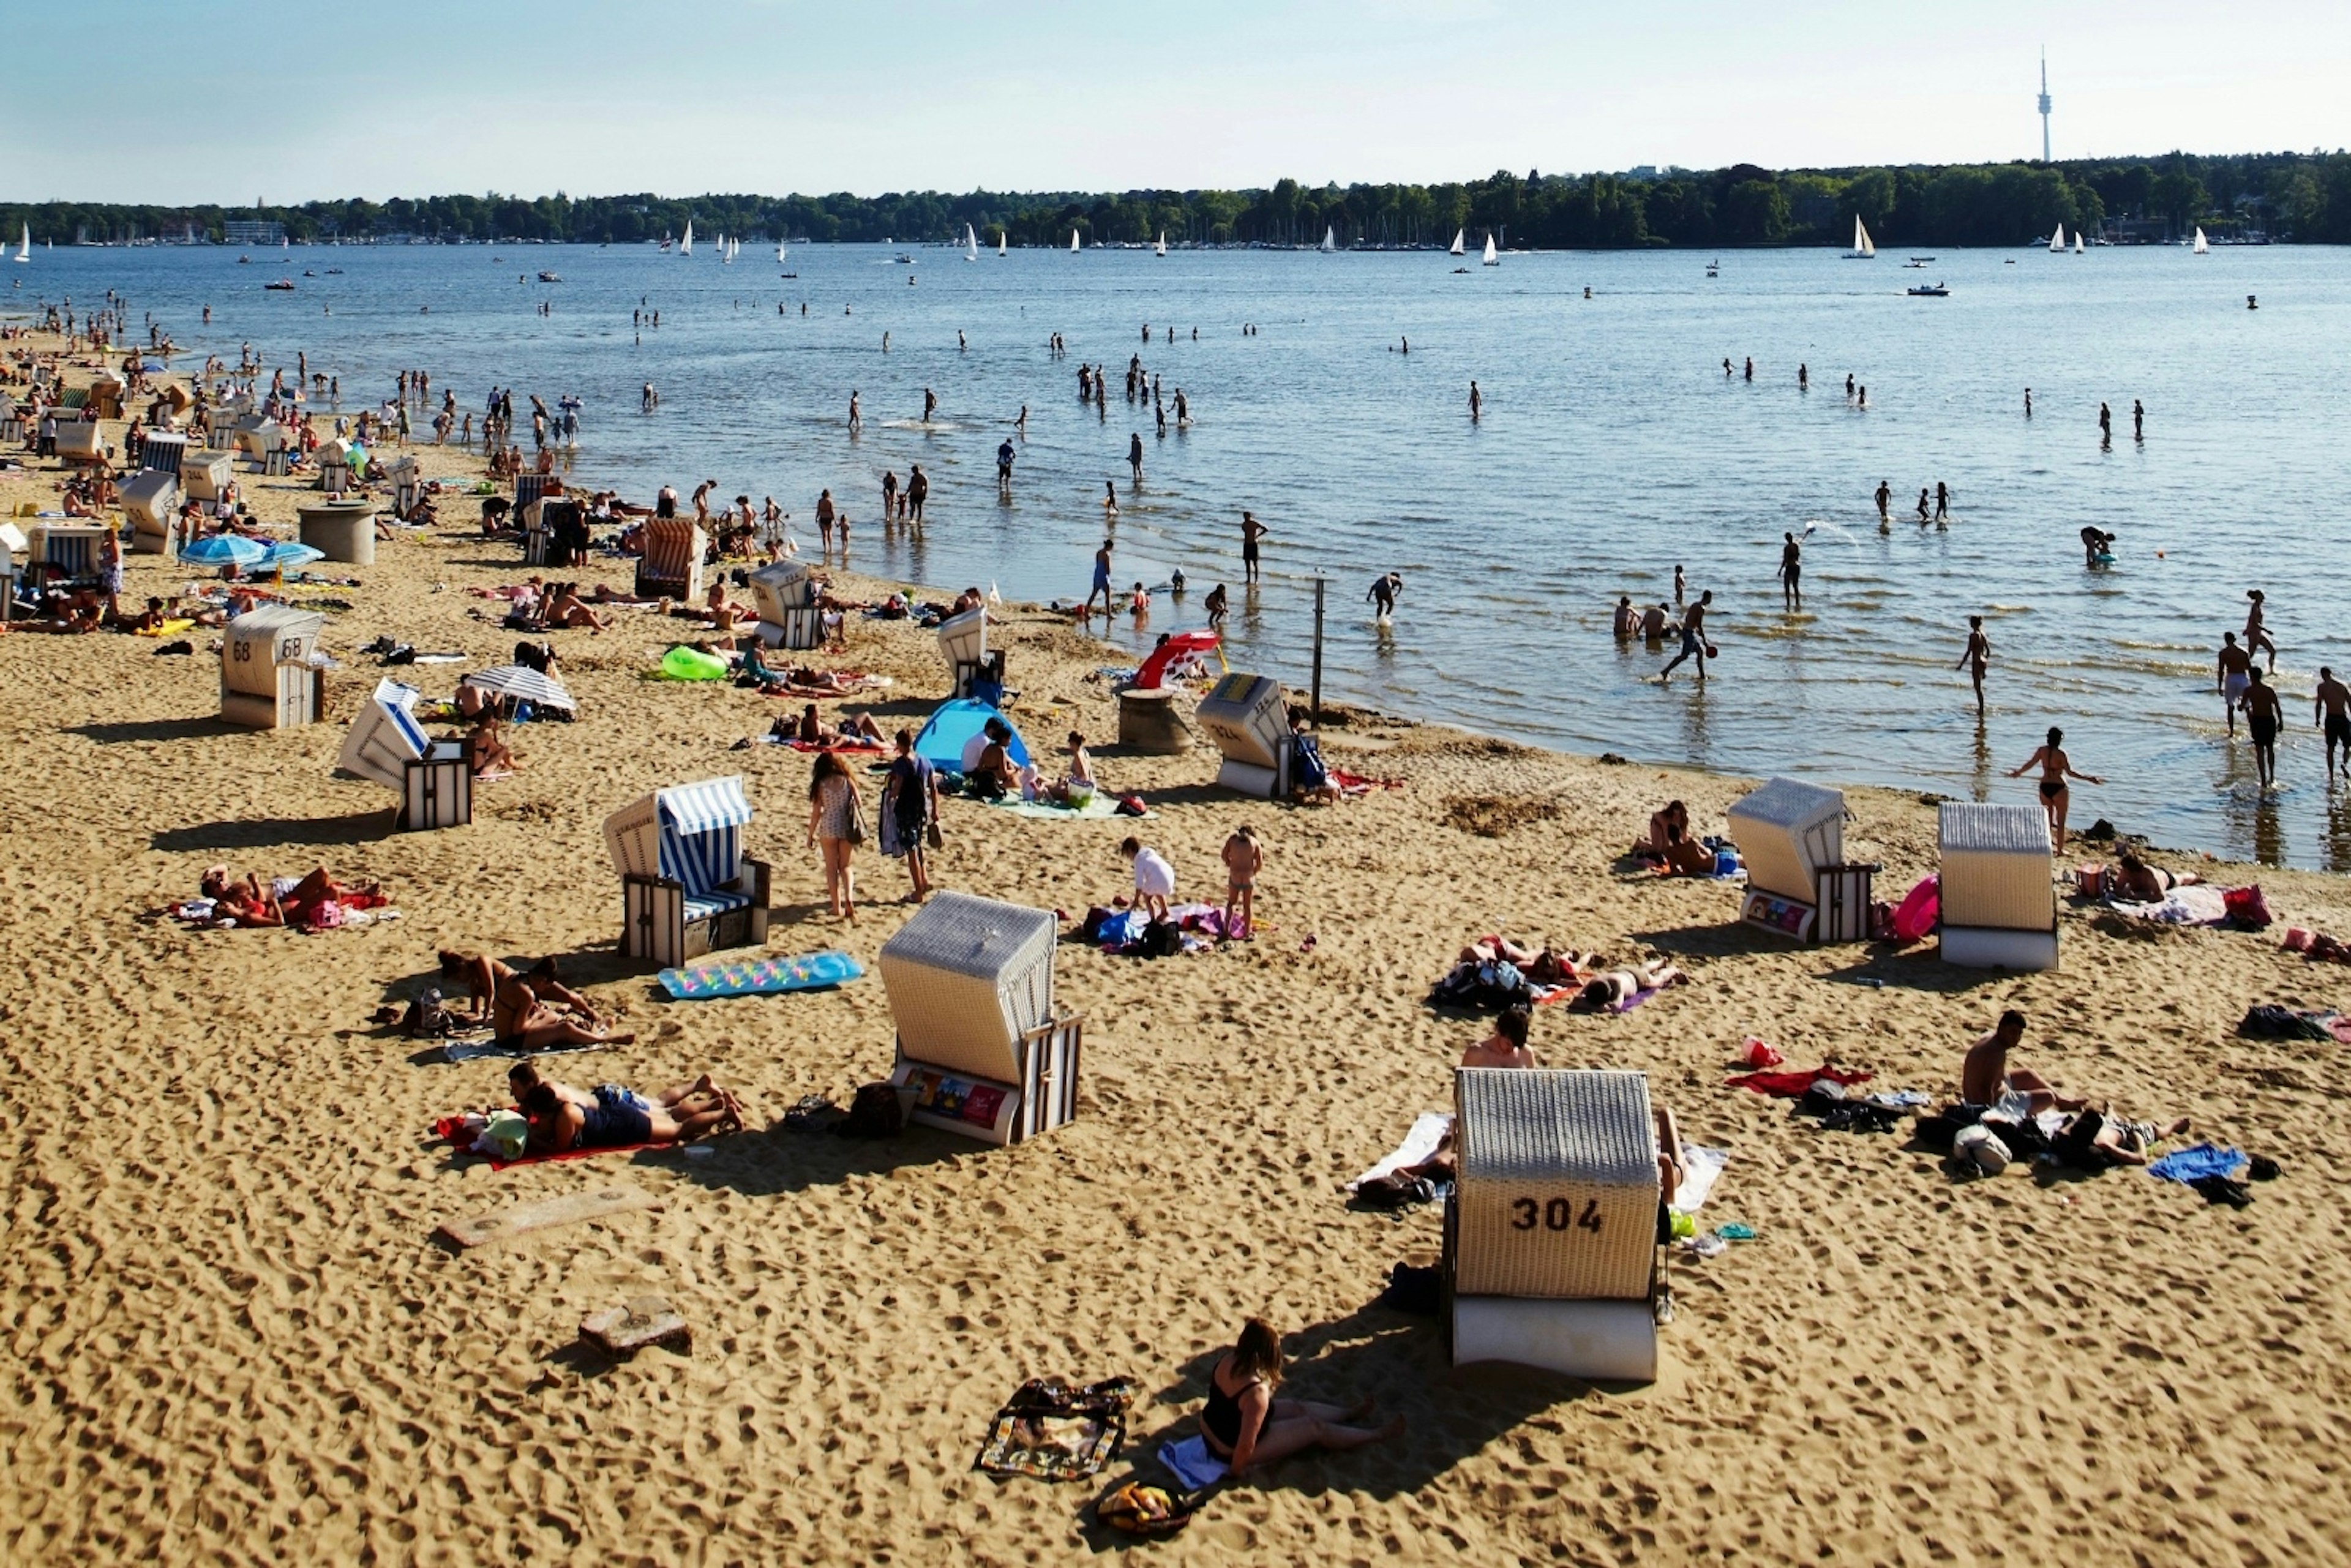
xmin=879 ymin=893 xmax=1084 ymax=1145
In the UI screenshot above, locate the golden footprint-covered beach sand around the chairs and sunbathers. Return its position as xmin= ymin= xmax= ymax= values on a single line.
xmin=0 ymin=338 xmax=2351 ymax=1563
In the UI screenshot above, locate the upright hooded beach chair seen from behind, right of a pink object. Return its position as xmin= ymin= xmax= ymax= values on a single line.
xmin=1935 ymin=801 xmax=2057 ymax=969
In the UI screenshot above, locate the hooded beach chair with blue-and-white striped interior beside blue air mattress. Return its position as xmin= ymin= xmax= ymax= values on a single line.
xmin=604 ymin=776 xmax=769 ymax=969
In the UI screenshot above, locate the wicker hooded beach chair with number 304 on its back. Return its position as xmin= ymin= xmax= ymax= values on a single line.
xmin=1444 ymin=1067 xmax=1679 ymax=1382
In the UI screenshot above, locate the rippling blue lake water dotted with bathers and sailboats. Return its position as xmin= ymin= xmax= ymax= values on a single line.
xmin=18 ymin=247 xmax=2351 ymax=870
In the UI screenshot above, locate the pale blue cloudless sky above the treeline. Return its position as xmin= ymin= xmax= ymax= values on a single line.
xmin=0 ymin=0 xmax=2351 ymax=204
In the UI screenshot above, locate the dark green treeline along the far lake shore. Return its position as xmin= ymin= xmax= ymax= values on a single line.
xmin=0 ymin=151 xmax=2351 ymax=249
